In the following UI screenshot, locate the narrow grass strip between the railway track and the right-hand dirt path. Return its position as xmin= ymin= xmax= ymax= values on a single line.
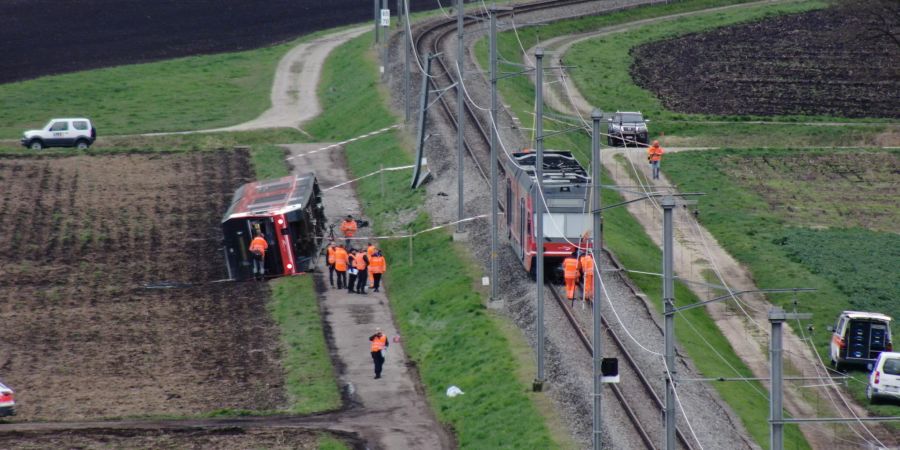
xmin=477 ymin=2 xmax=809 ymax=448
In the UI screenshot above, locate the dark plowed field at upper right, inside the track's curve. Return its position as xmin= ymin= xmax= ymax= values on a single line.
xmin=631 ymin=2 xmax=900 ymax=118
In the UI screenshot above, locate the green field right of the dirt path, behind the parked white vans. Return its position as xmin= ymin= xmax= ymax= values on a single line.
xmin=665 ymin=150 xmax=900 ymax=415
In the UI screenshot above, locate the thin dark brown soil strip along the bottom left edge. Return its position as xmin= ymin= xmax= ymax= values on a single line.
xmin=0 ymin=428 xmax=348 ymax=450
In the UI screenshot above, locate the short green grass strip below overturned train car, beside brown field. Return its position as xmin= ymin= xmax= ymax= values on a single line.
xmin=269 ymin=276 xmax=341 ymax=414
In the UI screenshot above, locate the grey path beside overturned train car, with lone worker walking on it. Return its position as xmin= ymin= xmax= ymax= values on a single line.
xmin=286 ymin=144 xmax=454 ymax=449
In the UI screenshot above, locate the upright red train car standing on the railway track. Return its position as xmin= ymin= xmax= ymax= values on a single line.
xmin=505 ymin=151 xmax=593 ymax=279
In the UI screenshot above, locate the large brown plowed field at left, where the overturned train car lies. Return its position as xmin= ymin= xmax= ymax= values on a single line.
xmin=0 ymin=152 xmax=284 ymax=420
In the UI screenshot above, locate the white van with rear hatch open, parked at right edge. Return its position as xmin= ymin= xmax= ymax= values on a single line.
xmin=830 ymin=311 xmax=893 ymax=370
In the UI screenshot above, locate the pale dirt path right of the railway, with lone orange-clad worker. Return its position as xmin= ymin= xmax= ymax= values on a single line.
xmin=524 ymin=1 xmax=884 ymax=448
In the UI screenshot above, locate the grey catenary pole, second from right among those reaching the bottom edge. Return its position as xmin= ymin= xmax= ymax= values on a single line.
xmin=660 ymin=196 xmax=675 ymax=450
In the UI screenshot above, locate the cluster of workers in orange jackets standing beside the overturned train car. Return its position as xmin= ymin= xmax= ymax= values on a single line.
xmin=326 ymin=241 xmax=387 ymax=294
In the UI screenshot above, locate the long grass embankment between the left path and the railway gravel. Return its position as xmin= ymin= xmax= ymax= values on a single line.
xmin=307 ymin=35 xmax=570 ymax=448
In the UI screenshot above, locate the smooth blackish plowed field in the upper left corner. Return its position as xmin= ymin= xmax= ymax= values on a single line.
xmin=0 ymin=0 xmax=436 ymax=83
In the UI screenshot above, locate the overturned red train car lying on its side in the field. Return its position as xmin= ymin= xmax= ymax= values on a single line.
xmin=222 ymin=172 xmax=325 ymax=280
